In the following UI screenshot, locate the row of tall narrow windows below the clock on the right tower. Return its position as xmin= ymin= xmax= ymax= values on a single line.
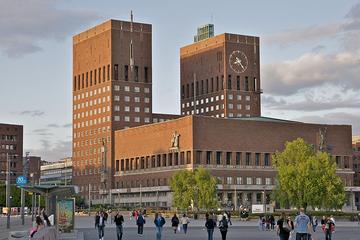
xmin=181 ymin=75 xmax=259 ymax=99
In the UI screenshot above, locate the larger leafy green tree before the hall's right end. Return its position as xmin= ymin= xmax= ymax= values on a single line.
xmin=273 ymin=138 xmax=345 ymax=209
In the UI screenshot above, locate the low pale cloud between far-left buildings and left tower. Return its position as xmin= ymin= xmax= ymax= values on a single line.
xmin=26 ymin=139 xmax=71 ymax=162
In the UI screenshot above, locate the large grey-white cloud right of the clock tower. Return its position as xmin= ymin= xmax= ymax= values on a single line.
xmin=262 ymin=53 xmax=360 ymax=95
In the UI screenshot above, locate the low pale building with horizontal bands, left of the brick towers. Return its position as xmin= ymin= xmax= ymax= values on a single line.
xmin=39 ymin=157 xmax=73 ymax=185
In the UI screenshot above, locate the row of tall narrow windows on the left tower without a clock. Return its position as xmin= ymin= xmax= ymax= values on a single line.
xmin=73 ymin=64 xmax=150 ymax=91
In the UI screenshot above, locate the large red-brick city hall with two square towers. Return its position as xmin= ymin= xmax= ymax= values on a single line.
xmin=73 ymin=19 xmax=356 ymax=208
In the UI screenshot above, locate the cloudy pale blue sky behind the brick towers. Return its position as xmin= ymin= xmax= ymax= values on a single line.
xmin=0 ymin=0 xmax=360 ymax=161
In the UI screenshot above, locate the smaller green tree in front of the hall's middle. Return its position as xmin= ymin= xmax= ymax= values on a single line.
xmin=170 ymin=167 xmax=218 ymax=209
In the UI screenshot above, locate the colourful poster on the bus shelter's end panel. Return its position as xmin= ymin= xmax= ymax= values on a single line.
xmin=56 ymin=198 xmax=75 ymax=232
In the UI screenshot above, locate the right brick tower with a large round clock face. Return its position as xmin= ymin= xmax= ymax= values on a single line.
xmin=180 ymin=33 xmax=262 ymax=118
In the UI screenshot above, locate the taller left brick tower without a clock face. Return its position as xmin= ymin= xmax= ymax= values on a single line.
xmin=73 ymin=17 xmax=177 ymax=202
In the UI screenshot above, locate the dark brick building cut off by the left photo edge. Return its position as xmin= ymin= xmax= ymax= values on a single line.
xmin=0 ymin=123 xmax=23 ymax=181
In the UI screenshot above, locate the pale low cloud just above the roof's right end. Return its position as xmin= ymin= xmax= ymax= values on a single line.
xmin=294 ymin=112 xmax=360 ymax=135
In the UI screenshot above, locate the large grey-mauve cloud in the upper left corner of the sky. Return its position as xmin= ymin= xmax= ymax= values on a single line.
xmin=0 ymin=0 xmax=98 ymax=57
